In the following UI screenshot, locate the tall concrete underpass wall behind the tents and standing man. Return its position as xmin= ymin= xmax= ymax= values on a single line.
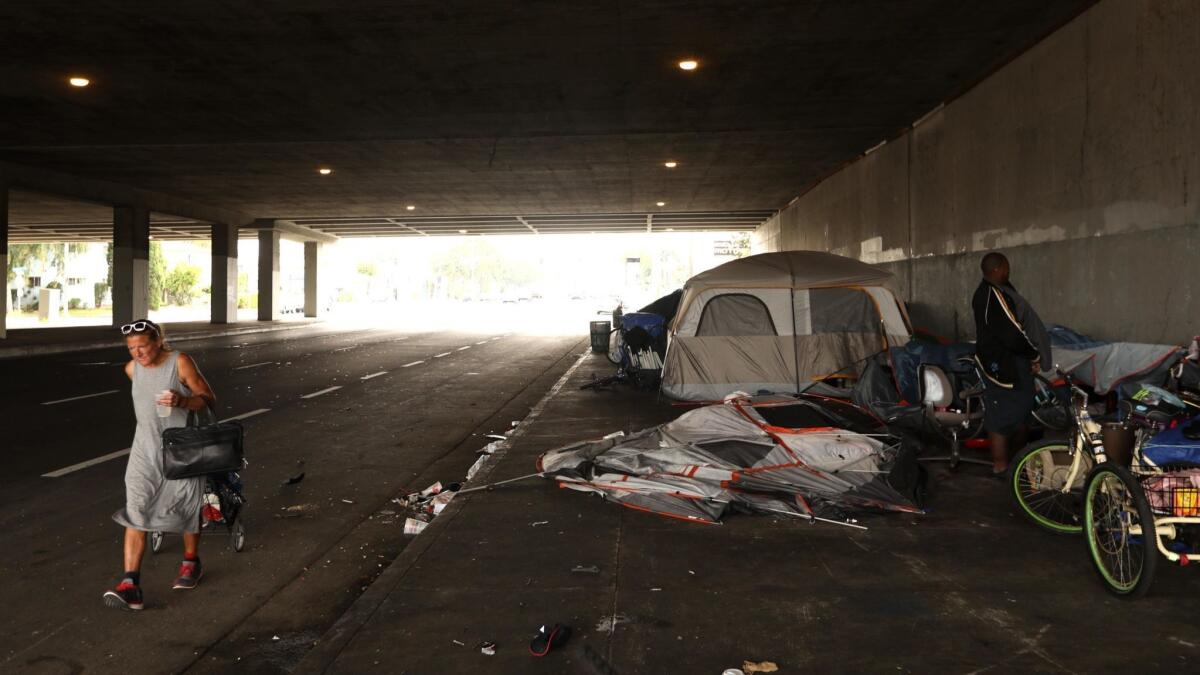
xmin=754 ymin=0 xmax=1200 ymax=342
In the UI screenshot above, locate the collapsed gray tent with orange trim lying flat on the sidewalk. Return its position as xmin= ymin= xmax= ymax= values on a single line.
xmin=538 ymin=396 xmax=920 ymax=524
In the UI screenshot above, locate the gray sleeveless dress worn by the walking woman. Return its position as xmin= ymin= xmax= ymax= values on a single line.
xmin=113 ymin=352 xmax=204 ymax=532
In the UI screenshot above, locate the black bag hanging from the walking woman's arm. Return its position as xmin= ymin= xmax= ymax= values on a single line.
xmin=162 ymin=406 xmax=246 ymax=480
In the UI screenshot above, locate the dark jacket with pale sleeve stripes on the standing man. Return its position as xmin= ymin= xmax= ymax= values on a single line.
xmin=971 ymin=279 xmax=1051 ymax=389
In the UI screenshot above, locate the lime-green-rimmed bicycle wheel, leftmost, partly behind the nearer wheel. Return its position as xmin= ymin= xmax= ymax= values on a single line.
xmin=1008 ymin=441 xmax=1094 ymax=534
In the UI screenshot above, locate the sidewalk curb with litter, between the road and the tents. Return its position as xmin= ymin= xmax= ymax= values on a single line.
xmin=292 ymin=350 xmax=592 ymax=675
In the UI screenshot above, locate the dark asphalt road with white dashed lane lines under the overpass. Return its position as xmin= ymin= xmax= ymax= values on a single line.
xmin=0 ymin=324 xmax=586 ymax=673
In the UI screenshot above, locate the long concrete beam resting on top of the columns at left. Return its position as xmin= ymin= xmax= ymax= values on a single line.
xmin=0 ymin=162 xmax=253 ymax=225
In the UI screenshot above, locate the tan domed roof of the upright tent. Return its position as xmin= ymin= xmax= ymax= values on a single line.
xmin=685 ymin=251 xmax=895 ymax=291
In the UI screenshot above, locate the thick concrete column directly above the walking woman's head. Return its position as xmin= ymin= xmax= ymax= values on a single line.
xmin=113 ymin=201 xmax=150 ymax=325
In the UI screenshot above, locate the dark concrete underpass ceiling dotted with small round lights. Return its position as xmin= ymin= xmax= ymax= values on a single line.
xmin=0 ymin=0 xmax=1091 ymax=235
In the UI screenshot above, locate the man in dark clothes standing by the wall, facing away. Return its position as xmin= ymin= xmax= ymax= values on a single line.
xmin=971 ymin=251 xmax=1051 ymax=476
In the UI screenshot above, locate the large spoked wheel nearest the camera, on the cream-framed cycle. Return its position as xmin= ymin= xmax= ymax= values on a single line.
xmin=1084 ymin=462 xmax=1158 ymax=598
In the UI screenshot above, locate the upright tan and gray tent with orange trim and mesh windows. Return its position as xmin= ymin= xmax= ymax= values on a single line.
xmin=662 ymin=251 xmax=910 ymax=401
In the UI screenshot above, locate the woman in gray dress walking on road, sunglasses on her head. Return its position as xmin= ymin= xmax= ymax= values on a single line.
xmin=104 ymin=319 xmax=216 ymax=609
